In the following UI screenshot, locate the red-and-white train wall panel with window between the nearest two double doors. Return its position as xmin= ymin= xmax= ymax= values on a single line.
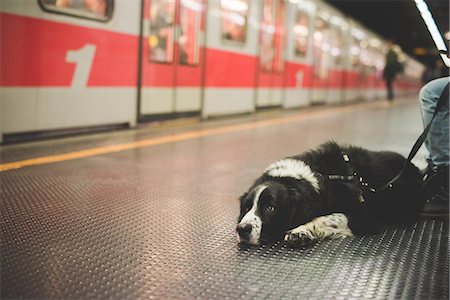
xmin=202 ymin=0 xmax=260 ymax=119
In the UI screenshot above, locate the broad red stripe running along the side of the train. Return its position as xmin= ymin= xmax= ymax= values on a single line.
xmin=0 ymin=13 xmax=419 ymax=89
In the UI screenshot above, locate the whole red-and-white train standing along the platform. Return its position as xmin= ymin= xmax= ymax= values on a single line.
xmin=0 ymin=0 xmax=424 ymax=143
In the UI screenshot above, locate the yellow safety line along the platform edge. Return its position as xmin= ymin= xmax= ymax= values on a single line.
xmin=0 ymin=102 xmax=386 ymax=172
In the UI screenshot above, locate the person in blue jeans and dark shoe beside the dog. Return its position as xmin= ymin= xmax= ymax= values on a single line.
xmin=419 ymin=76 xmax=450 ymax=216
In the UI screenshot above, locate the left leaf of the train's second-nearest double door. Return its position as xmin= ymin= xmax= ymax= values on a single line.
xmin=256 ymin=0 xmax=277 ymax=107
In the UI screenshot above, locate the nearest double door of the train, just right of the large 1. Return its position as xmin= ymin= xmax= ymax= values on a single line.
xmin=139 ymin=0 xmax=205 ymax=120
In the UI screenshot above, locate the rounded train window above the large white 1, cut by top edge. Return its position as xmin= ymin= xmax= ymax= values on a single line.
xmin=38 ymin=0 xmax=114 ymax=21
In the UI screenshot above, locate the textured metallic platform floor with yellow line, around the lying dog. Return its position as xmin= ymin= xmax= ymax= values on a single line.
xmin=0 ymin=98 xmax=449 ymax=299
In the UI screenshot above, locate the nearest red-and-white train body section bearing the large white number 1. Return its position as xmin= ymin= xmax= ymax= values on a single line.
xmin=0 ymin=0 xmax=140 ymax=141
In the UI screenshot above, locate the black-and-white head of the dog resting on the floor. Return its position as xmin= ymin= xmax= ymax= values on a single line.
xmin=236 ymin=180 xmax=319 ymax=245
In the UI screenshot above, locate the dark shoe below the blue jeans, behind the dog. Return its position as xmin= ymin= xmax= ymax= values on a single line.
xmin=421 ymin=166 xmax=449 ymax=217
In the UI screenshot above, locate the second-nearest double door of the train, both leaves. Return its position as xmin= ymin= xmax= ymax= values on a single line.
xmin=256 ymin=0 xmax=286 ymax=108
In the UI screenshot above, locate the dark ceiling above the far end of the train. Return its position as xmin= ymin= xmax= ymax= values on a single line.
xmin=326 ymin=0 xmax=449 ymax=64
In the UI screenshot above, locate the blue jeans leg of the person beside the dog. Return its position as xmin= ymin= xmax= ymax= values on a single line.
xmin=419 ymin=77 xmax=450 ymax=167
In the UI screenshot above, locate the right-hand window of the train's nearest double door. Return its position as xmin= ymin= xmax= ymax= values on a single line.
xmin=178 ymin=0 xmax=203 ymax=66
